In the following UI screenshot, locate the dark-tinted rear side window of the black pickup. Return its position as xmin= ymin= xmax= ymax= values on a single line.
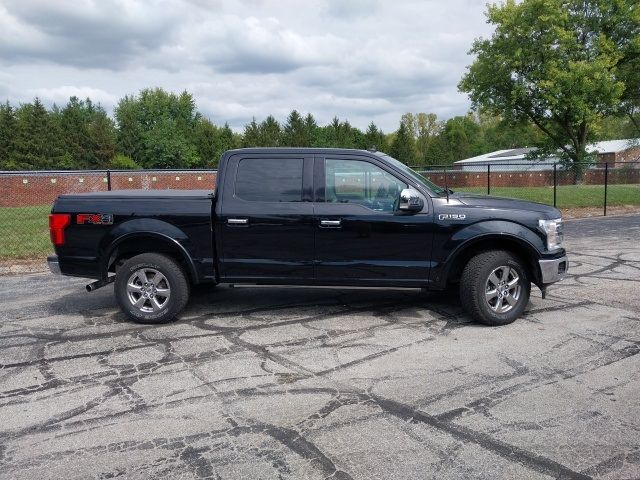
xmin=236 ymin=158 xmax=303 ymax=202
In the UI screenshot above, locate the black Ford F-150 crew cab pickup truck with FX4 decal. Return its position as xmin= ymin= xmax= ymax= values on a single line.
xmin=48 ymin=148 xmax=568 ymax=325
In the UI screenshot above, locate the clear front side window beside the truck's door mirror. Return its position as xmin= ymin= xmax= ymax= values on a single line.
xmin=325 ymin=158 xmax=407 ymax=212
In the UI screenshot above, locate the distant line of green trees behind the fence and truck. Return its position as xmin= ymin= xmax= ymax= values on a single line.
xmin=0 ymin=88 xmax=634 ymax=170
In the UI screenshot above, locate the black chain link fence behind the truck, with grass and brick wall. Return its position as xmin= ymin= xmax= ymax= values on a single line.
xmin=0 ymin=162 xmax=640 ymax=274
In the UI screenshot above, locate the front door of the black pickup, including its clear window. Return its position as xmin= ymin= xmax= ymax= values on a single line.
xmin=314 ymin=155 xmax=433 ymax=287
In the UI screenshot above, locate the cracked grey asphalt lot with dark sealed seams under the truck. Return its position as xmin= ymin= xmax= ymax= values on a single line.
xmin=0 ymin=216 xmax=640 ymax=479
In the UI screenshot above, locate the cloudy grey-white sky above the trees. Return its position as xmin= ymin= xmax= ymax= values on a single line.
xmin=0 ymin=0 xmax=491 ymax=131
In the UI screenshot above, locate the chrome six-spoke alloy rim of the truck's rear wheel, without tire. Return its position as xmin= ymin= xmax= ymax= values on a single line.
xmin=127 ymin=268 xmax=171 ymax=313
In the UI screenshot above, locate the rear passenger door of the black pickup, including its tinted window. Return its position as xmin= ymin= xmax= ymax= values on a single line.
xmin=217 ymin=153 xmax=314 ymax=283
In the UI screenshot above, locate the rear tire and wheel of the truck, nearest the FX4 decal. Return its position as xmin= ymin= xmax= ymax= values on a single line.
xmin=114 ymin=253 xmax=190 ymax=324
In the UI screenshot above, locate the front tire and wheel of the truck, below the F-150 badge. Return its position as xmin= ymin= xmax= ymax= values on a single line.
xmin=460 ymin=250 xmax=531 ymax=326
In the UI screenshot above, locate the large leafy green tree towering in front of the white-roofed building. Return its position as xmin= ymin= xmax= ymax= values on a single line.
xmin=459 ymin=0 xmax=638 ymax=169
